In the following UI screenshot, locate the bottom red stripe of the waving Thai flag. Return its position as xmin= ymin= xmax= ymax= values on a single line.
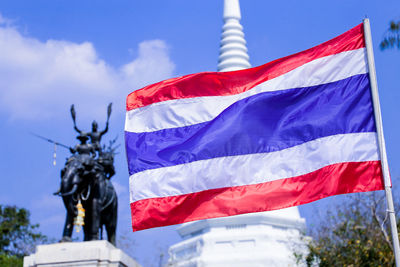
xmin=131 ymin=161 xmax=384 ymax=231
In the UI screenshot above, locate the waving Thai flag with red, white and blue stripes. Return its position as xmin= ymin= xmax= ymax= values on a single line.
xmin=125 ymin=24 xmax=384 ymax=231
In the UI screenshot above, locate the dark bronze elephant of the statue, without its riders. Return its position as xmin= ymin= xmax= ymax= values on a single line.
xmin=56 ymin=152 xmax=118 ymax=245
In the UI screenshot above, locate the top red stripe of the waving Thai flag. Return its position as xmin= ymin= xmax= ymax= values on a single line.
xmin=126 ymin=24 xmax=365 ymax=111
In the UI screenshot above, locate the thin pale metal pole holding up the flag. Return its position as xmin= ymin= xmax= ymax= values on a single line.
xmin=363 ymin=18 xmax=400 ymax=267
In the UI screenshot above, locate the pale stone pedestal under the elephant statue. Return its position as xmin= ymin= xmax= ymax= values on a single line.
xmin=24 ymin=240 xmax=140 ymax=267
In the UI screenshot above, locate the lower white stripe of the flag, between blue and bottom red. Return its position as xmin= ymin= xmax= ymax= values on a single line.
xmin=129 ymin=133 xmax=379 ymax=202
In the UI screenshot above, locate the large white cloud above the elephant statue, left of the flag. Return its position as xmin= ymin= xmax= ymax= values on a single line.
xmin=0 ymin=15 xmax=175 ymax=120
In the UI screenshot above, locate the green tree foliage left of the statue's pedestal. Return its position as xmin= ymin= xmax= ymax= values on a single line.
xmin=0 ymin=205 xmax=47 ymax=266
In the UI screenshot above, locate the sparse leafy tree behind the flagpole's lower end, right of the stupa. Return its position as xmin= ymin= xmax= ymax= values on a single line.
xmin=295 ymin=192 xmax=394 ymax=267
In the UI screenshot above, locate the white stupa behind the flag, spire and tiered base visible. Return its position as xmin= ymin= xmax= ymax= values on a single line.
xmin=168 ymin=0 xmax=305 ymax=267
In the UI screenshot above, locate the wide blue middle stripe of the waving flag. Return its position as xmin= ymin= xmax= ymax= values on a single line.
xmin=125 ymin=74 xmax=375 ymax=175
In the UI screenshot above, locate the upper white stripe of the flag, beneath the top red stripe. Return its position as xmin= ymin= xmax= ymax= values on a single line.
xmin=125 ymin=48 xmax=368 ymax=133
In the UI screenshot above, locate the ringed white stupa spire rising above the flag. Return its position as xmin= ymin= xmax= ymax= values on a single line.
xmin=218 ymin=0 xmax=251 ymax=71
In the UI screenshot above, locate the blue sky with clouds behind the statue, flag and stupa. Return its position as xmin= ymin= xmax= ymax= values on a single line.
xmin=0 ymin=0 xmax=400 ymax=266
